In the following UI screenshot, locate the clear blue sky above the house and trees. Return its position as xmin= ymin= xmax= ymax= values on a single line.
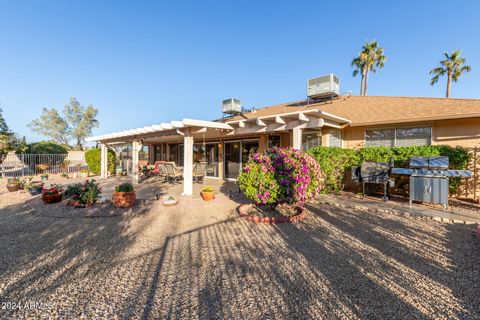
xmin=0 ymin=0 xmax=480 ymax=141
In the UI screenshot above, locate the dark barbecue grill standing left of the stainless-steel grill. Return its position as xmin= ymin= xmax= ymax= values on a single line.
xmin=352 ymin=161 xmax=394 ymax=201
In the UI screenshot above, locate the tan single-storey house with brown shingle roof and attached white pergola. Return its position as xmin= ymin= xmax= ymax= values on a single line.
xmin=89 ymin=95 xmax=480 ymax=194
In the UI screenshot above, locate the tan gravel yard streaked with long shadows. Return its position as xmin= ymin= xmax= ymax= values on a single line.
xmin=0 ymin=190 xmax=480 ymax=319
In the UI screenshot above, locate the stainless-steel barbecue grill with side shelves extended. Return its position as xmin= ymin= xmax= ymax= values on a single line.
xmin=391 ymin=157 xmax=472 ymax=210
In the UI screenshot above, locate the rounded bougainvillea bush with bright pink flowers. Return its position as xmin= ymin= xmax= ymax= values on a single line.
xmin=238 ymin=148 xmax=324 ymax=206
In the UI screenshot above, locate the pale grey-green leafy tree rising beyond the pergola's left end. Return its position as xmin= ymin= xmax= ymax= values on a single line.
xmin=29 ymin=98 xmax=99 ymax=150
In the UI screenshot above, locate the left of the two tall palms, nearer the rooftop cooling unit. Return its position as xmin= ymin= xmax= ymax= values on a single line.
xmin=352 ymin=40 xmax=387 ymax=96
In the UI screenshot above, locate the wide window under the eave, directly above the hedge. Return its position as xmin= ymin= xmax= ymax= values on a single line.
xmin=365 ymin=127 xmax=432 ymax=147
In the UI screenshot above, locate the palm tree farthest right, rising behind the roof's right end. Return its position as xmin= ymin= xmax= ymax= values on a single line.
xmin=430 ymin=50 xmax=472 ymax=98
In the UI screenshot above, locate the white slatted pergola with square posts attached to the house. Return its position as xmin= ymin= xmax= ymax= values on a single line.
xmin=87 ymin=109 xmax=350 ymax=195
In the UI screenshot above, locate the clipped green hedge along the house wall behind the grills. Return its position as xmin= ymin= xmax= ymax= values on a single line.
xmin=308 ymin=145 xmax=470 ymax=192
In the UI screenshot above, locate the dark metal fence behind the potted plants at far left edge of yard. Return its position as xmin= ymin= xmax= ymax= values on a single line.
xmin=0 ymin=153 xmax=88 ymax=178
